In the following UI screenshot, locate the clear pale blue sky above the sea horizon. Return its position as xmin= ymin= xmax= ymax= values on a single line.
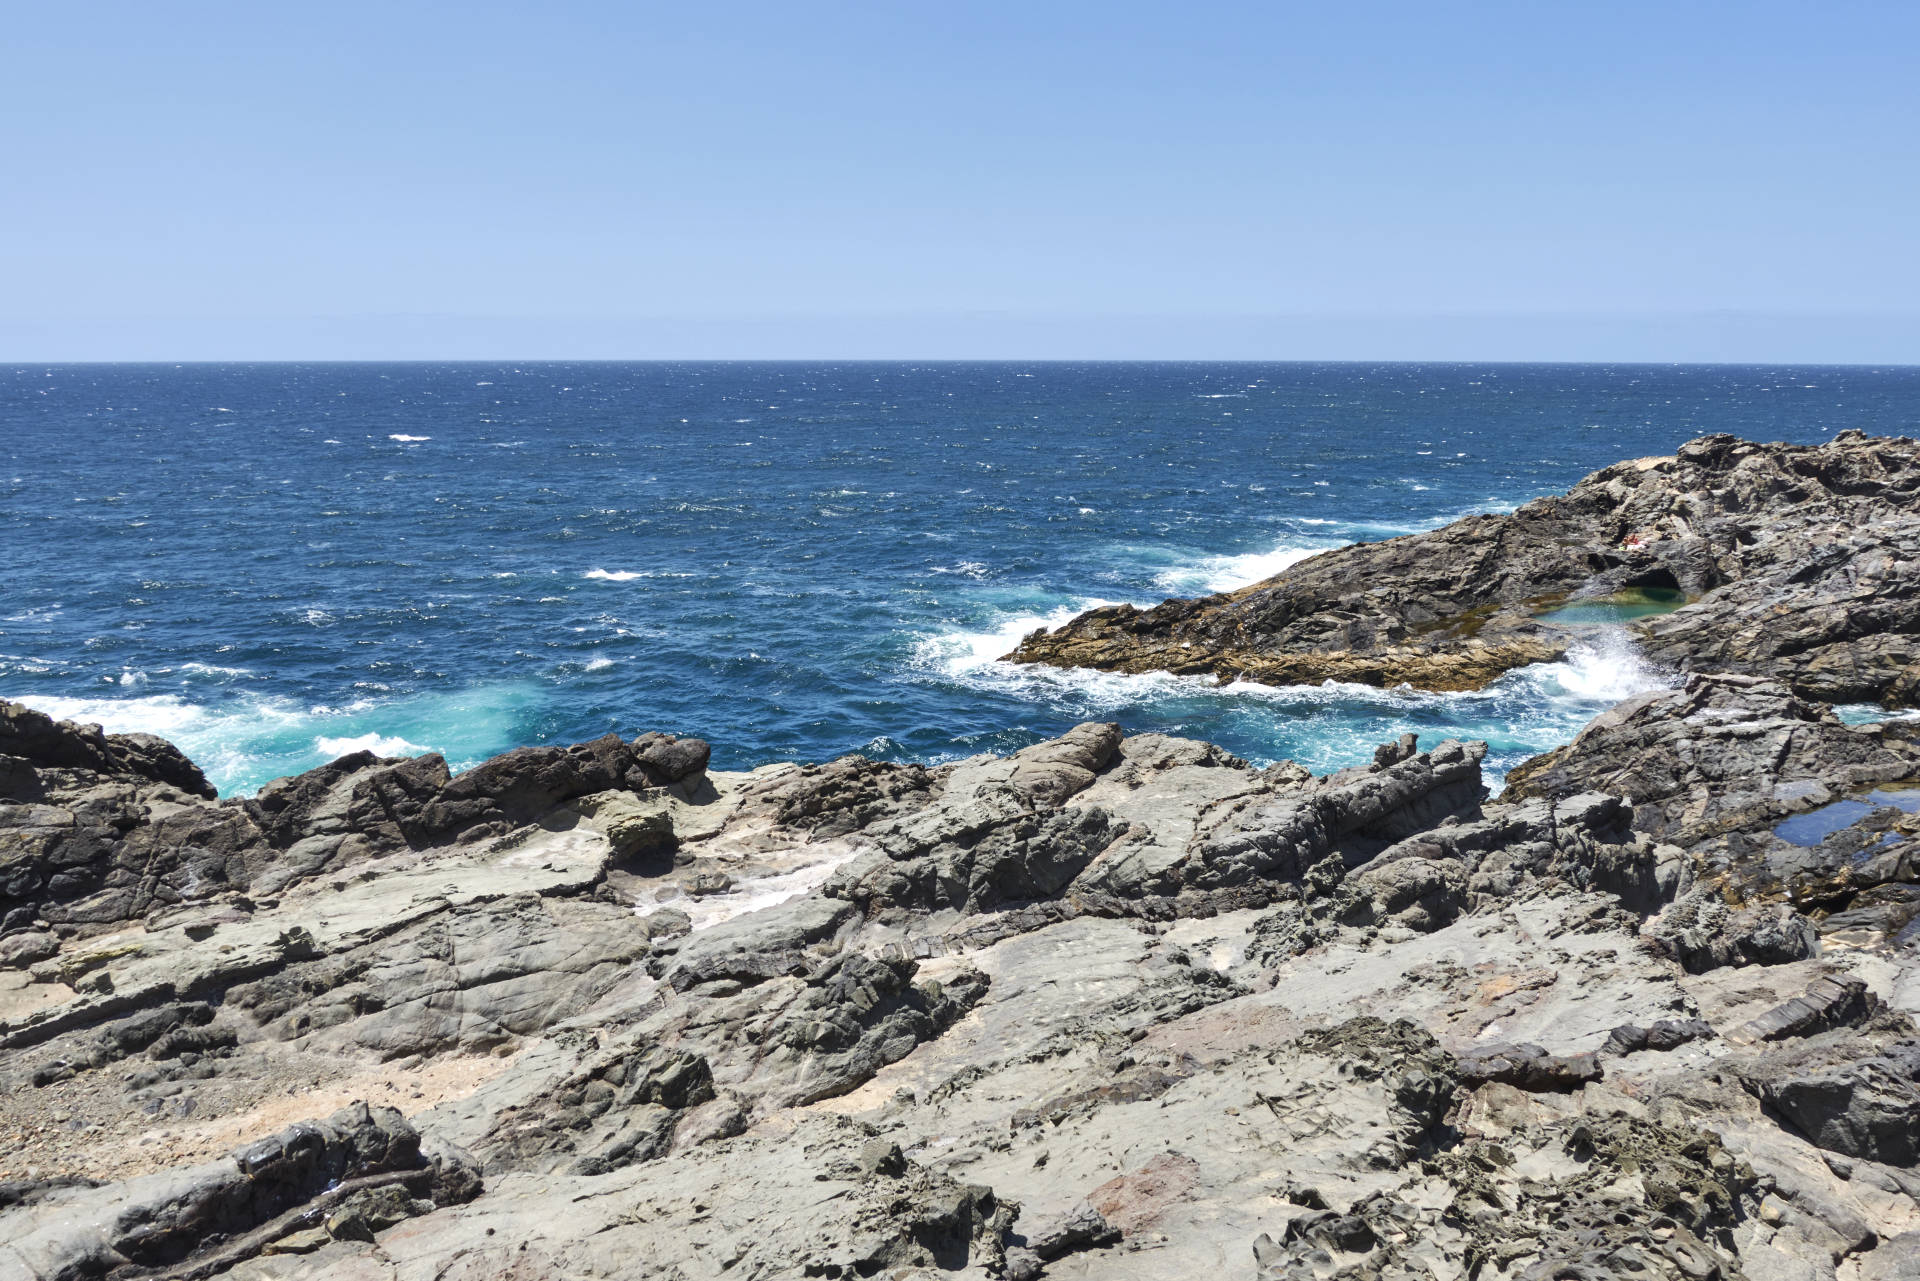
xmin=0 ymin=0 xmax=1920 ymax=363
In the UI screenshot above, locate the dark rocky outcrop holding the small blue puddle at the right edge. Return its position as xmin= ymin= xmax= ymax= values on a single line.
xmin=1505 ymin=674 xmax=1920 ymax=956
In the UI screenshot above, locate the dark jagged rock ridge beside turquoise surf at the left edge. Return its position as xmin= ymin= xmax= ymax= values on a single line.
xmin=0 ymin=701 xmax=708 ymax=930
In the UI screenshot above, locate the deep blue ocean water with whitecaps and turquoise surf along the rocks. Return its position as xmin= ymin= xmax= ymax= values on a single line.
xmin=0 ymin=363 xmax=1920 ymax=791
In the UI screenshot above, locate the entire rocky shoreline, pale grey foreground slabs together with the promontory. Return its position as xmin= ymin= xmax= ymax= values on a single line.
xmin=0 ymin=434 xmax=1920 ymax=1281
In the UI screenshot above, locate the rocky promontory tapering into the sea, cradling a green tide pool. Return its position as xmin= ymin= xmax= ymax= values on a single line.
xmin=1008 ymin=432 xmax=1920 ymax=707
